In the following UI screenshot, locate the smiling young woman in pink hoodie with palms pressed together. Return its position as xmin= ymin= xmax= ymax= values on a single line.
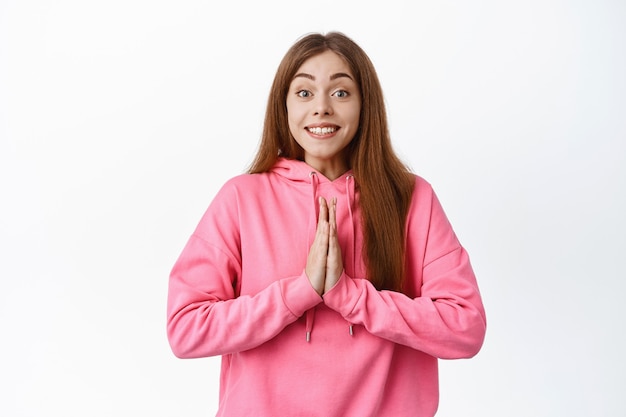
xmin=167 ymin=33 xmax=485 ymax=417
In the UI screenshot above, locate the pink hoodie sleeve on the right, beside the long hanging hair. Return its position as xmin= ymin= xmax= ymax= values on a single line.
xmin=324 ymin=180 xmax=486 ymax=359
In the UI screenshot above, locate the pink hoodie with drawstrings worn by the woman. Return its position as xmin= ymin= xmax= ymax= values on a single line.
xmin=167 ymin=159 xmax=485 ymax=417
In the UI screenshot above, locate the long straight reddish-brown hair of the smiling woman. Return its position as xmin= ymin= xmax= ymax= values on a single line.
xmin=248 ymin=32 xmax=415 ymax=291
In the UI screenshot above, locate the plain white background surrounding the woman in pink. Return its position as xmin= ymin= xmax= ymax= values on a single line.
xmin=0 ymin=0 xmax=626 ymax=417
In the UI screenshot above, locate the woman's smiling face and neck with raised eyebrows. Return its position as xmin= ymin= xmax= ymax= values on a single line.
xmin=287 ymin=51 xmax=361 ymax=180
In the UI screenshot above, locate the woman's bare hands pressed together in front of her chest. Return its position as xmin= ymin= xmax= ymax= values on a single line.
xmin=305 ymin=197 xmax=343 ymax=296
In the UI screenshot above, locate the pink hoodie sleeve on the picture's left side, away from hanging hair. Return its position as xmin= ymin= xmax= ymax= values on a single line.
xmin=167 ymin=180 xmax=321 ymax=358
